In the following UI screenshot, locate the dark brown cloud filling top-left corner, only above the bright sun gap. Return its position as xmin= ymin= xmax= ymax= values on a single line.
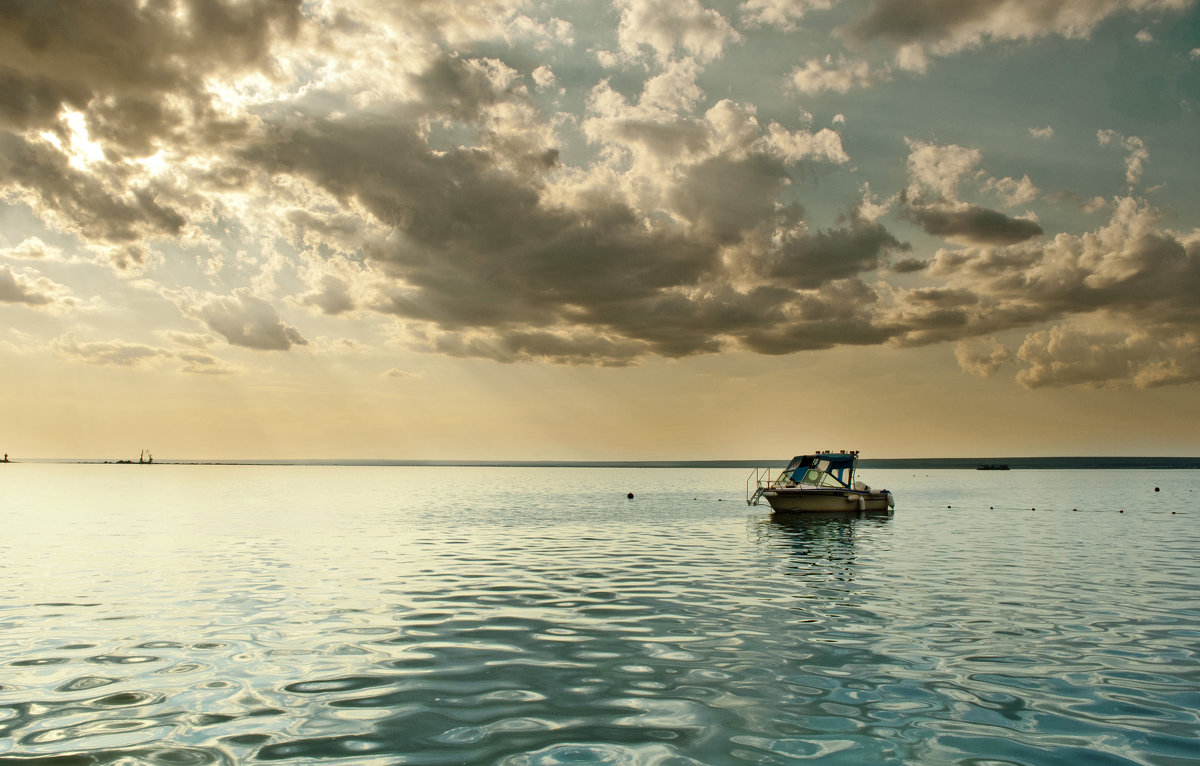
xmin=0 ymin=0 xmax=301 ymax=145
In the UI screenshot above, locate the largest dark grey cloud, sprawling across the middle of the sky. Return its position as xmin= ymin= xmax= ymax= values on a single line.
xmin=246 ymin=115 xmax=716 ymax=327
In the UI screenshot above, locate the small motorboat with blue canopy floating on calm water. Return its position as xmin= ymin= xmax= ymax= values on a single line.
xmin=746 ymin=450 xmax=895 ymax=513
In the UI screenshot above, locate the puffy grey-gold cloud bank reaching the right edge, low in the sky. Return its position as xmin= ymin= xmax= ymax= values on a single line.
xmin=895 ymin=199 xmax=1200 ymax=374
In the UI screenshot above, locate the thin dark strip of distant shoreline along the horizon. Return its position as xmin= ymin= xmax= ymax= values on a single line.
xmin=10 ymin=456 xmax=1200 ymax=471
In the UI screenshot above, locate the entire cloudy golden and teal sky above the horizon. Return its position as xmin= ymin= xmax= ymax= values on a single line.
xmin=0 ymin=0 xmax=1200 ymax=460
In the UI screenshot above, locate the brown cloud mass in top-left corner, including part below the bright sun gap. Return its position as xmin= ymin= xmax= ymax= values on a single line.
xmin=0 ymin=0 xmax=301 ymax=261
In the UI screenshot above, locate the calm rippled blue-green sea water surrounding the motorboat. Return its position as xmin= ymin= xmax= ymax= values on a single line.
xmin=0 ymin=465 xmax=1200 ymax=766
